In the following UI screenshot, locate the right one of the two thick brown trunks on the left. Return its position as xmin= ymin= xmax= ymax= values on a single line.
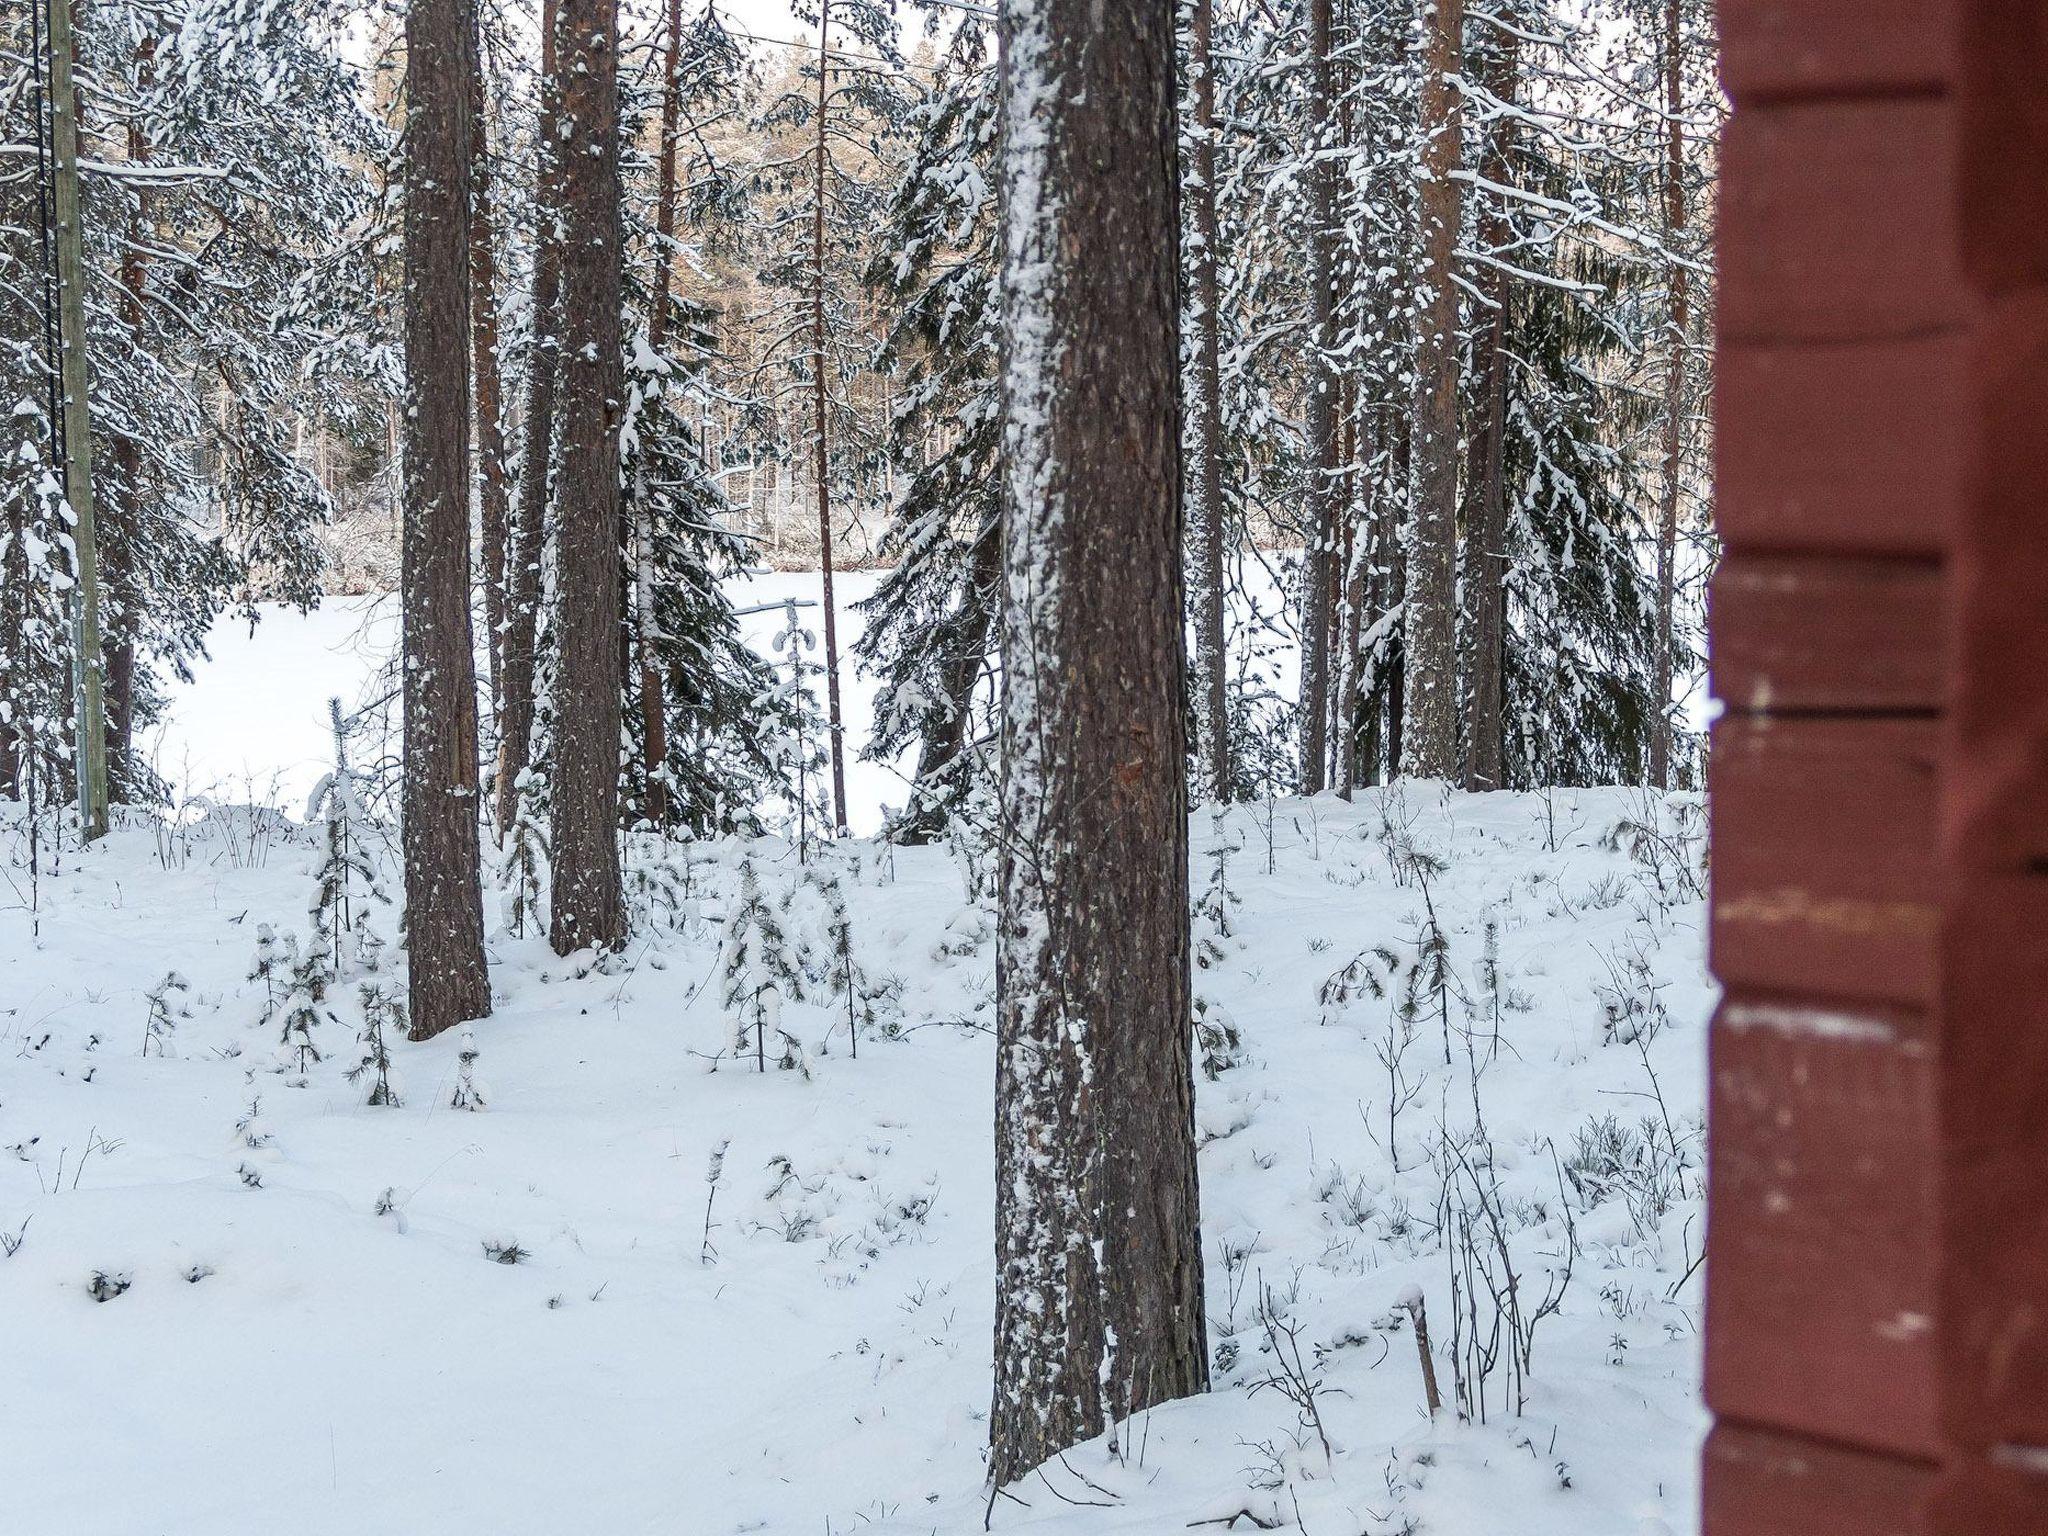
xmin=549 ymin=0 xmax=625 ymax=954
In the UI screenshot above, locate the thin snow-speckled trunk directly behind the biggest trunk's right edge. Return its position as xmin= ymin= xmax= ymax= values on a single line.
xmin=1190 ymin=0 xmax=1231 ymax=801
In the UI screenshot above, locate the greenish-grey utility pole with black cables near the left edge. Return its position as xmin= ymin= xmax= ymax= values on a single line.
xmin=49 ymin=0 xmax=106 ymax=842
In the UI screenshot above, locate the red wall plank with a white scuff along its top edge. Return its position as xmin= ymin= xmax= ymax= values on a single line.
xmin=1706 ymin=993 xmax=1939 ymax=1456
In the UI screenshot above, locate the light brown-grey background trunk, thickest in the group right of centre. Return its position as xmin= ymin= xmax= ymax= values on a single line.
xmin=1401 ymin=0 xmax=1464 ymax=778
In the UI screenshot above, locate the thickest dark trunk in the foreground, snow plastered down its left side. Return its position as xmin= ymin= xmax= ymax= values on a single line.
xmin=989 ymin=0 xmax=1206 ymax=1485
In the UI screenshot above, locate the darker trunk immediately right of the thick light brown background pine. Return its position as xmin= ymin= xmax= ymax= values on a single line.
xmin=1464 ymin=31 xmax=1522 ymax=791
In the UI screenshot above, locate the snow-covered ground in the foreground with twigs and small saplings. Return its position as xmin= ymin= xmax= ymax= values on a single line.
xmin=0 ymin=786 xmax=1710 ymax=1536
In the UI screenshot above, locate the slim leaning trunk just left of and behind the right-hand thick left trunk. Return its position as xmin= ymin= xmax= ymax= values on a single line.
xmin=498 ymin=0 xmax=561 ymax=836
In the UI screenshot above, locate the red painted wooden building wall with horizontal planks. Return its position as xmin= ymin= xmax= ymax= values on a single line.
xmin=1704 ymin=0 xmax=2048 ymax=1536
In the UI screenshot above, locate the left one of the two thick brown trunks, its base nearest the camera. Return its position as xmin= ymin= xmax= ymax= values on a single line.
xmin=399 ymin=0 xmax=492 ymax=1040
